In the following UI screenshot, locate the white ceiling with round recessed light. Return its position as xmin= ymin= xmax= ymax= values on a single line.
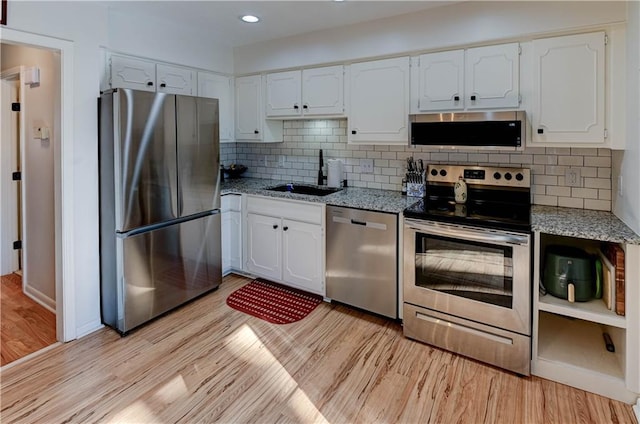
xmin=106 ymin=0 xmax=460 ymax=47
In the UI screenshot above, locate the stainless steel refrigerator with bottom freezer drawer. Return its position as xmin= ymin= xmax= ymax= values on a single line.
xmin=99 ymin=89 xmax=222 ymax=335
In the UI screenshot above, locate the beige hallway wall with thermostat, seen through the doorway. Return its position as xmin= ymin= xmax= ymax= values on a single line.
xmin=0 ymin=44 xmax=60 ymax=307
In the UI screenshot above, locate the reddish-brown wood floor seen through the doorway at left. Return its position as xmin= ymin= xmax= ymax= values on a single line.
xmin=0 ymin=274 xmax=56 ymax=365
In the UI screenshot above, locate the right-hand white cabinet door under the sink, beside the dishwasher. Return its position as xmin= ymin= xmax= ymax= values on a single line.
xmin=282 ymin=219 xmax=324 ymax=296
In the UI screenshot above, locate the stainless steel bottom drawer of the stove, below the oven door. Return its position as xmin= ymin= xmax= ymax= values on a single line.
xmin=402 ymin=303 xmax=531 ymax=375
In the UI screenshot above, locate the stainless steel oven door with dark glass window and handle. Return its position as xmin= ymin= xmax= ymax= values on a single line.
xmin=403 ymin=219 xmax=531 ymax=335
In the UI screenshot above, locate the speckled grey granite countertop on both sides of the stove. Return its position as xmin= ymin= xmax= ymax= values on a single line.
xmin=221 ymin=178 xmax=640 ymax=244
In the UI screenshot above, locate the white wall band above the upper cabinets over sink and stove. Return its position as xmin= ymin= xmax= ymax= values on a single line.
xmin=234 ymin=1 xmax=626 ymax=74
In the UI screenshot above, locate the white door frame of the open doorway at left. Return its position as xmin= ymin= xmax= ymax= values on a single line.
xmin=0 ymin=28 xmax=77 ymax=342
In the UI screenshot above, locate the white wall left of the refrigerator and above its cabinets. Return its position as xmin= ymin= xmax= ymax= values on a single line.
xmin=5 ymin=1 xmax=233 ymax=336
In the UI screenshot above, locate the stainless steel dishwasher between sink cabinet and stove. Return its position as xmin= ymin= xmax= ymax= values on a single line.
xmin=326 ymin=206 xmax=398 ymax=319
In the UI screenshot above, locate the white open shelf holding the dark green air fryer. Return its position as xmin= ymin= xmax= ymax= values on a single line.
xmin=538 ymin=294 xmax=627 ymax=328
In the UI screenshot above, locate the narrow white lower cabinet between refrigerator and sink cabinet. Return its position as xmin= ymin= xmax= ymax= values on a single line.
xmin=221 ymin=194 xmax=242 ymax=275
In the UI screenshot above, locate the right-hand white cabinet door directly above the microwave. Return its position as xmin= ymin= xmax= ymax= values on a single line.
xmin=465 ymin=43 xmax=520 ymax=109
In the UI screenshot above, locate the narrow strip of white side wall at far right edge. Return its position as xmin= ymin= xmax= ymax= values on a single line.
xmin=614 ymin=1 xmax=640 ymax=233
